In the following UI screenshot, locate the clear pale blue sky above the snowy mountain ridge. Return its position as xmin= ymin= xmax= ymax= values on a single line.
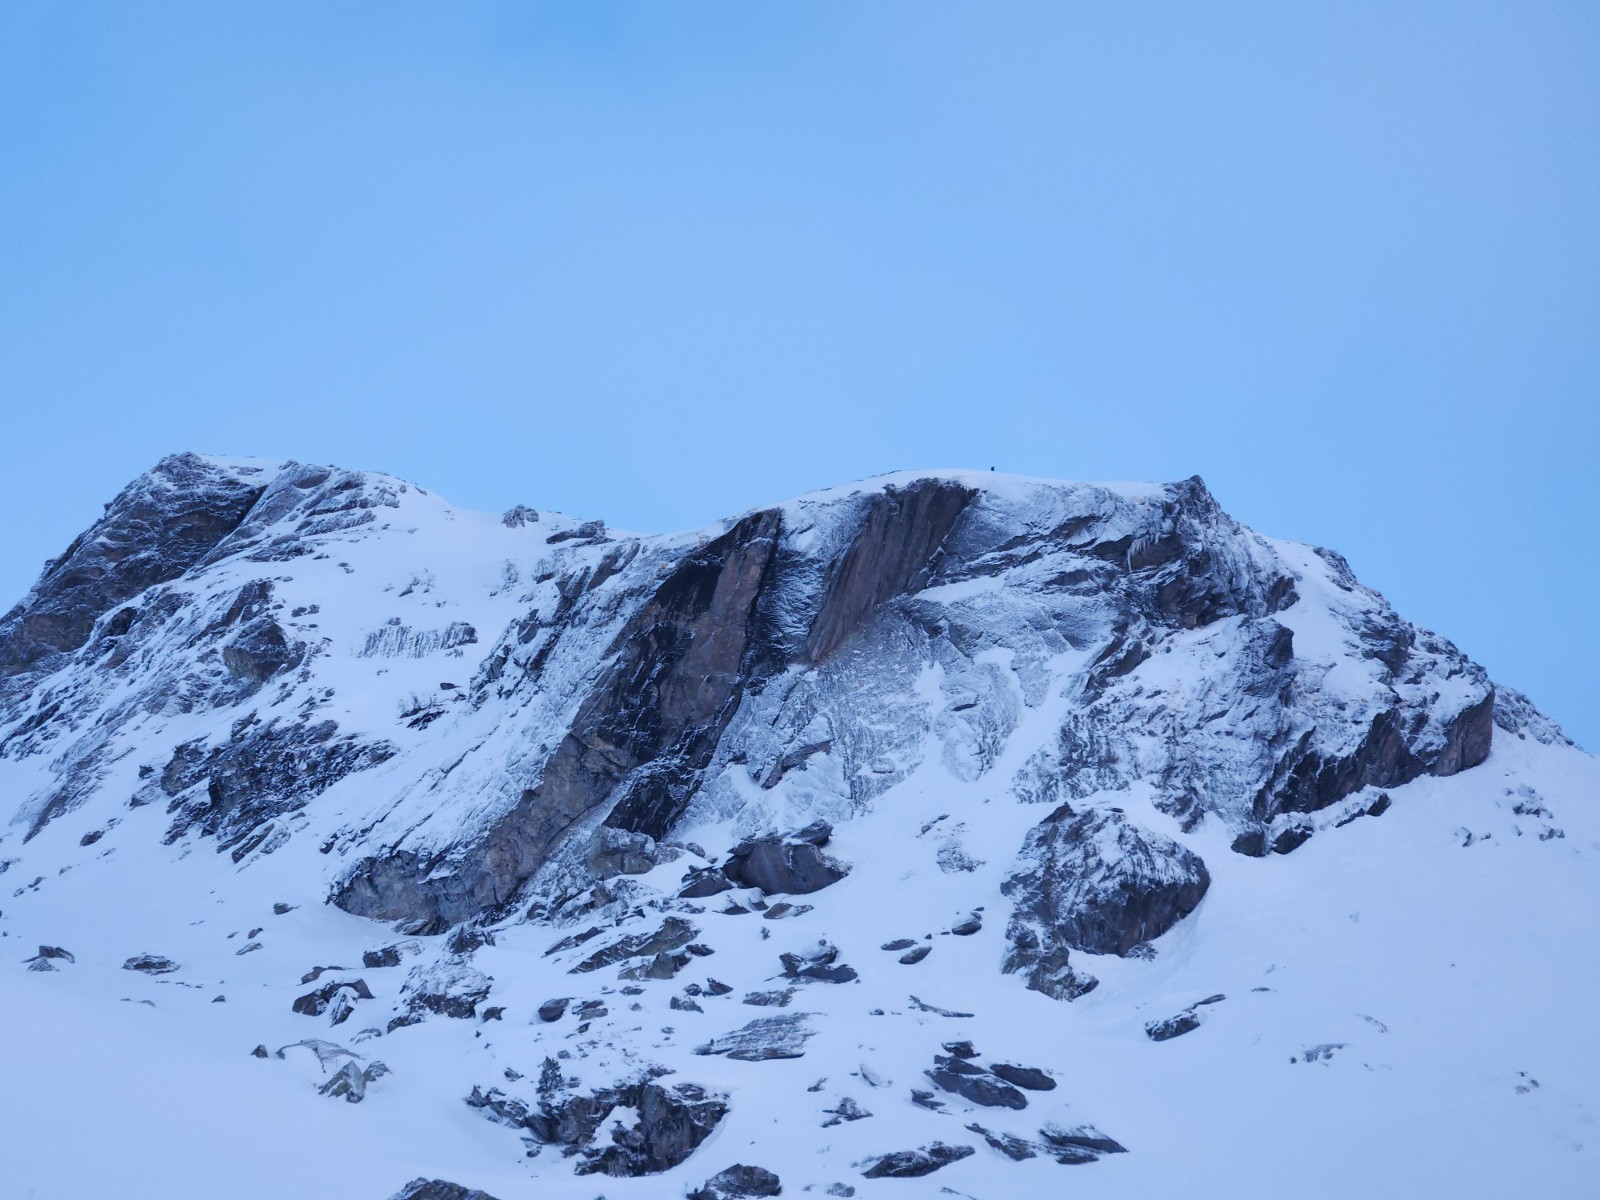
xmin=0 ymin=0 xmax=1600 ymax=747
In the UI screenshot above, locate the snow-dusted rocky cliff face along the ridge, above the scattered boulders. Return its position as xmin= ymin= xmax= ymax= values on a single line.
xmin=0 ymin=454 xmax=1529 ymax=949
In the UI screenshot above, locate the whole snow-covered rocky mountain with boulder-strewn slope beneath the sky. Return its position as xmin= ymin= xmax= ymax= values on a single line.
xmin=0 ymin=454 xmax=1600 ymax=1200
